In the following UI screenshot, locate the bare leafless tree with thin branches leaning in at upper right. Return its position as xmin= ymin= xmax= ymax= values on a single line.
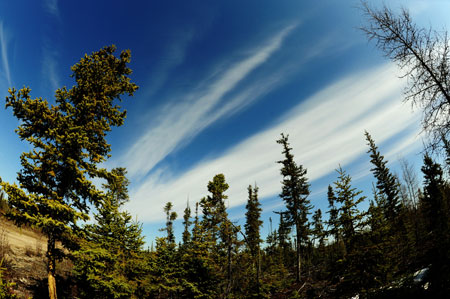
xmin=361 ymin=2 xmax=450 ymax=148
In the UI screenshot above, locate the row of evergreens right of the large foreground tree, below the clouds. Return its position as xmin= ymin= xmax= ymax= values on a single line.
xmin=62 ymin=132 xmax=450 ymax=298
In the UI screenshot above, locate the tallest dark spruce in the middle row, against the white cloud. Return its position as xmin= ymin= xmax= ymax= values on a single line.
xmin=277 ymin=134 xmax=312 ymax=282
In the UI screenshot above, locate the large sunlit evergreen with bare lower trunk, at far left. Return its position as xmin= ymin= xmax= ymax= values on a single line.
xmin=2 ymin=46 xmax=137 ymax=299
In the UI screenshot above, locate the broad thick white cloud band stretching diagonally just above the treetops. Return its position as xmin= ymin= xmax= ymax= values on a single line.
xmin=127 ymin=66 xmax=419 ymax=221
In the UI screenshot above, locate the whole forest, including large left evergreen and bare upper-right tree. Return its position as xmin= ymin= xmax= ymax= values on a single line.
xmin=0 ymin=3 xmax=450 ymax=299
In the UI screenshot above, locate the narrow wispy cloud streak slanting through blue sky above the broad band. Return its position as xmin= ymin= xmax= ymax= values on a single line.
xmin=121 ymin=25 xmax=295 ymax=177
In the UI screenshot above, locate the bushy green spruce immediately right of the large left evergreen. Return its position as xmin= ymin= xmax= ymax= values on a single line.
xmin=73 ymin=168 xmax=145 ymax=299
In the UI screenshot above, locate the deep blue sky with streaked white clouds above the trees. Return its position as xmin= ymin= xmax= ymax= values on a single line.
xmin=0 ymin=0 xmax=450 ymax=243
